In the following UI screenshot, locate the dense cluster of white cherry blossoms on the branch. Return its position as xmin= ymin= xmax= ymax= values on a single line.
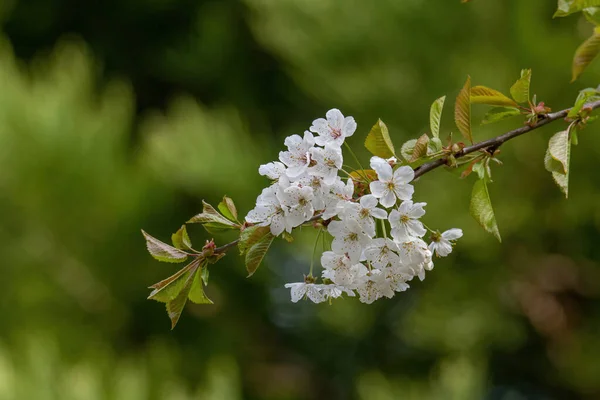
xmin=246 ymin=109 xmax=462 ymax=303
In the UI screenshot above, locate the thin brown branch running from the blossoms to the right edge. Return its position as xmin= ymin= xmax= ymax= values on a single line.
xmin=415 ymin=100 xmax=600 ymax=179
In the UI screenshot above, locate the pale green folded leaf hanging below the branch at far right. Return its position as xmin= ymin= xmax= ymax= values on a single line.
xmin=544 ymin=131 xmax=571 ymax=198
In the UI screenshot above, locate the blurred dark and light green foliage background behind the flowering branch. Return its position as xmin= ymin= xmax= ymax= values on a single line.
xmin=0 ymin=0 xmax=600 ymax=400
